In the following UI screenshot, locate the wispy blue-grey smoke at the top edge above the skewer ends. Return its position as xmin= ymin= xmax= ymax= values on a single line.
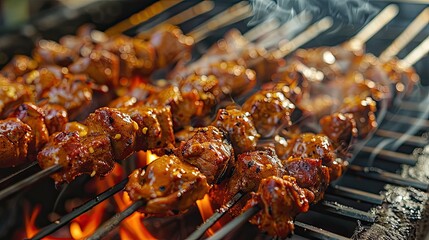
xmin=249 ymin=0 xmax=379 ymax=26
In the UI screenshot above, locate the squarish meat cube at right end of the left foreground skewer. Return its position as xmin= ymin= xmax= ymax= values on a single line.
xmin=119 ymin=105 xmax=174 ymax=151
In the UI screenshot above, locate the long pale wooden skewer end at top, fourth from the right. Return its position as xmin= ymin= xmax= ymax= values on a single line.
xmin=273 ymin=17 xmax=333 ymax=59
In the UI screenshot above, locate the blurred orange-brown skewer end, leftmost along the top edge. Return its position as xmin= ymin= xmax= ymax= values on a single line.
xmin=105 ymin=0 xmax=183 ymax=36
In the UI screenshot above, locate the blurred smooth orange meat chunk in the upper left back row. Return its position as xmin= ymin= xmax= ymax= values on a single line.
xmin=69 ymin=50 xmax=119 ymax=86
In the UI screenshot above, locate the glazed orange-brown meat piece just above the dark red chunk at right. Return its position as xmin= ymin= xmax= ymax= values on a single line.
xmin=286 ymin=133 xmax=335 ymax=166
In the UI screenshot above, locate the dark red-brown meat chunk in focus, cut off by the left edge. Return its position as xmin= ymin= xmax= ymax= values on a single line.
xmin=0 ymin=118 xmax=33 ymax=168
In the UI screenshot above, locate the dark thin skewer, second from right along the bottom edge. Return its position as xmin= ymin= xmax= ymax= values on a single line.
xmin=185 ymin=192 xmax=244 ymax=240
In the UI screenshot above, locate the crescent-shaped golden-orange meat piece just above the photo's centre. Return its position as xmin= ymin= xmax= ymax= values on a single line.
xmin=179 ymin=74 xmax=222 ymax=116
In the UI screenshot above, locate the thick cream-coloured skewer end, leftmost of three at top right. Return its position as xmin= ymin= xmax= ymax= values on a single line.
xmin=351 ymin=4 xmax=399 ymax=44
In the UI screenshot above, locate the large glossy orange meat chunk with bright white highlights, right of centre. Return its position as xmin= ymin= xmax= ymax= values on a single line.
xmin=243 ymin=90 xmax=295 ymax=138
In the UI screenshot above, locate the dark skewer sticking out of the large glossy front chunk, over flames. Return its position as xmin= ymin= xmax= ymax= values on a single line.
xmin=87 ymin=201 xmax=146 ymax=240
